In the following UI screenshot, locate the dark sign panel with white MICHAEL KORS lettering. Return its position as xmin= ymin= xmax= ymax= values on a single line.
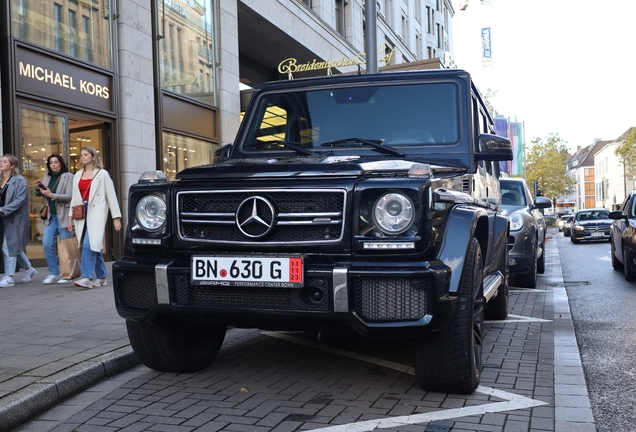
xmin=15 ymin=45 xmax=114 ymax=114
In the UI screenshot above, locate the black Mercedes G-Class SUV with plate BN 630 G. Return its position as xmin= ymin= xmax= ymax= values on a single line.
xmin=113 ymin=69 xmax=512 ymax=393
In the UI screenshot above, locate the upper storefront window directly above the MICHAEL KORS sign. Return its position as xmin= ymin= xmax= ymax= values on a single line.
xmin=12 ymin=0 xmax=113 ymax=69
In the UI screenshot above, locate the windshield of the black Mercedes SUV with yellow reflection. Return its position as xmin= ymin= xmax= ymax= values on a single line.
xmin=243 ymin=83 xmax=459 ymax=151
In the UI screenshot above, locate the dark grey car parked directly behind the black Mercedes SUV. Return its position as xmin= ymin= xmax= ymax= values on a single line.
xmin=499 ymin=178 xmax=552 ymax=288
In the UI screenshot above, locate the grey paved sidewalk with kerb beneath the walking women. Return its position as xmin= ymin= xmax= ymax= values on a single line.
xmin=0 ymin=263 xmax=139 ymax=431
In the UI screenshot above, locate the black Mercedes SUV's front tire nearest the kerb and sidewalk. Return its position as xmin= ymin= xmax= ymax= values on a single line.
xmin=126 ymin=319 xmax=227 ymax=373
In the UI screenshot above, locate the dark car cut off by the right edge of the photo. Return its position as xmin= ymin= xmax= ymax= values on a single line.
xmin=609 ymin=191 xmax=636 ymax=281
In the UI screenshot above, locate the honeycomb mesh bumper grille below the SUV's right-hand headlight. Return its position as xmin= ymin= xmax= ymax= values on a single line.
xmin=354 ymin=278 xmax=428 ymax=321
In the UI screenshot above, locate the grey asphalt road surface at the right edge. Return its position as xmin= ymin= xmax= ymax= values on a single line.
xmin=556 ymin=233 xmax=636 ymax=432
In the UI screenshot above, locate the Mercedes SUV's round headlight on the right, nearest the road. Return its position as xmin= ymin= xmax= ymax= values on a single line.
xmin=373 ymin=193 xmax=415 ymax=234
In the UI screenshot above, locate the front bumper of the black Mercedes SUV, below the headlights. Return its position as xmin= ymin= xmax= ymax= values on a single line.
xmin=113 ymin=258 xmax=456 ymax=336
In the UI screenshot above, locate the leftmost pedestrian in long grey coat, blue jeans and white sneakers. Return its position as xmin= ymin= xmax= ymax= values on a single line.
xmin=0 ymin=153 xmax=37 ymax=287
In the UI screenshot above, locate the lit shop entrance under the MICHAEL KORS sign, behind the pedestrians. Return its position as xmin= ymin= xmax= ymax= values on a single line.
xmin=17 ymin=105 xmax=111 ymax=267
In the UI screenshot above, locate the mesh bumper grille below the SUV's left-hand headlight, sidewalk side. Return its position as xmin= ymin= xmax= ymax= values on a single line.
xmin=113 ymin=270 xmax=157 ymax=309
